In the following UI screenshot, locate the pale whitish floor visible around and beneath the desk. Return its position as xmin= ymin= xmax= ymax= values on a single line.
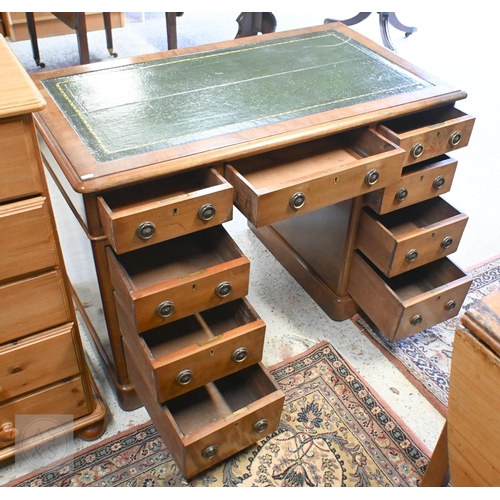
xmin=0 ymin=8 xmax=500 ymax=484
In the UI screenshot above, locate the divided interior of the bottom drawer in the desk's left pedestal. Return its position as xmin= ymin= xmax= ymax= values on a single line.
xmin=164 ymin=364 xmax=277 ymax=435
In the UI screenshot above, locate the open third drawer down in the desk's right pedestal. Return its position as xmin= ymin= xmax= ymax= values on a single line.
xmin=355 ymin=198 xmax=468 ymax=277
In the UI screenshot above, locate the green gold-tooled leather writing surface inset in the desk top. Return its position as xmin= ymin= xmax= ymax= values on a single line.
xmin=42 ymin=29 xmax=432 ymax=163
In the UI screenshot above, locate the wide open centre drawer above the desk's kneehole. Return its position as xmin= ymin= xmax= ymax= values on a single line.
xmin=224 ymin=128 xmax=404 ymax=227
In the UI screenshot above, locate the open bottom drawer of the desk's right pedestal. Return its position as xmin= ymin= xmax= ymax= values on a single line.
xmin=347 ymin=250 xmax=472 ymax=342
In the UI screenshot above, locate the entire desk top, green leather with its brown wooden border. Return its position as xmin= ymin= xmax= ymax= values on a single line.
xmin=33 ymin=23 xmax=466 ymax=193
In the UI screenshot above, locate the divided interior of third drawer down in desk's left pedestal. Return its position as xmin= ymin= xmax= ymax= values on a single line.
xmin=142 ymin=299 xmax=256 ymax=359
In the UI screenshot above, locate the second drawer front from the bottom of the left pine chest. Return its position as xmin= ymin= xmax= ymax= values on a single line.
xmin=0 ymin=323 xmax=80 ymax=401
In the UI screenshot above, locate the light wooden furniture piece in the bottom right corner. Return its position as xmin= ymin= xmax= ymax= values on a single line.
xmin=422 ymin=290 xmax=500 ymax=486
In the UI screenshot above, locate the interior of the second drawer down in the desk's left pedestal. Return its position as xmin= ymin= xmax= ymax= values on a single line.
xmin=110 ymin=226 xmax=242 ymax=289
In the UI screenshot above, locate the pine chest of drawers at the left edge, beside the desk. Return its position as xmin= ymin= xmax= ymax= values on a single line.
xmin=0 ymin=37 xmax=106 ymax=460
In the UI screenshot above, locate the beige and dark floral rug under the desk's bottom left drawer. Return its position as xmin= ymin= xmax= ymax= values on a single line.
xmin=7 ymin=342 xmax=430 ymax=487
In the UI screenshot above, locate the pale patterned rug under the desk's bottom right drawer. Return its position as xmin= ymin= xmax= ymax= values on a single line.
xmin=352 ymin=256 xmax=500 ymax=417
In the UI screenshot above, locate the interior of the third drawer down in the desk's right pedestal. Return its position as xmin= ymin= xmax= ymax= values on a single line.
xmin=365 ymin=198 xmax=461 ymax=237
